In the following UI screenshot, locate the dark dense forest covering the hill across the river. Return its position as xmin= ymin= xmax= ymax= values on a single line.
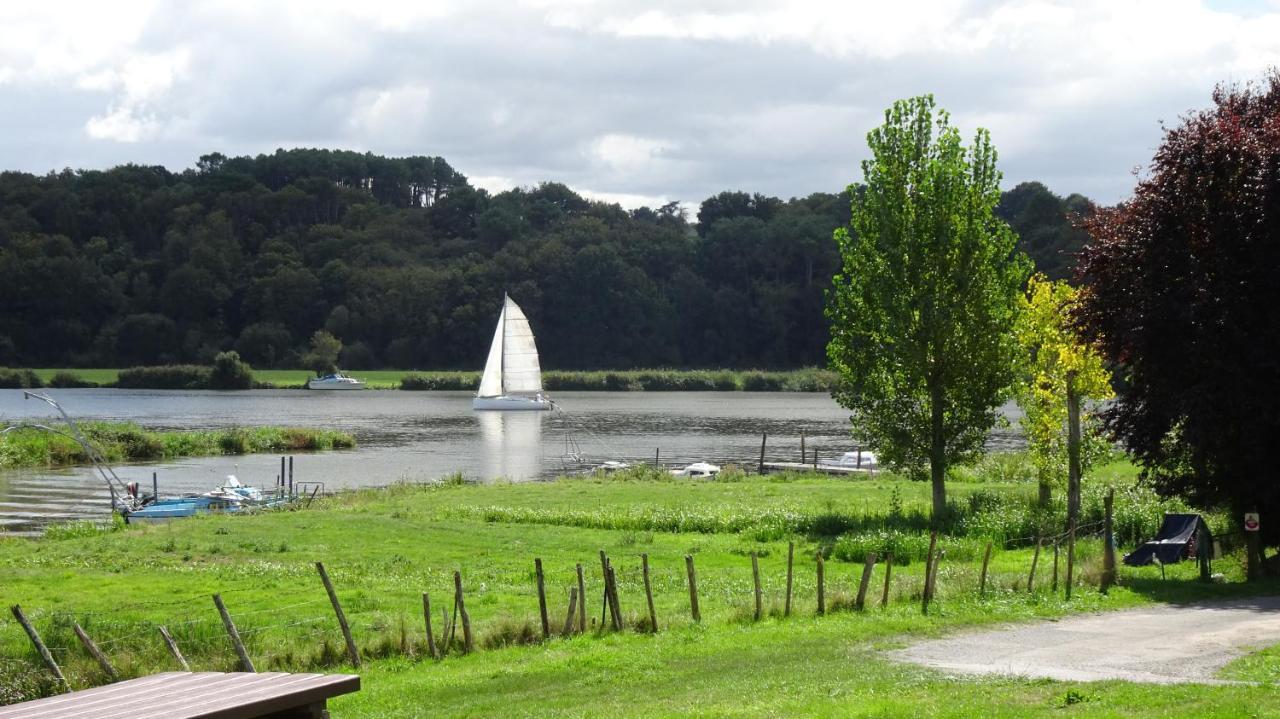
xmin=0 ymin=150 xmax=1093 ymax=370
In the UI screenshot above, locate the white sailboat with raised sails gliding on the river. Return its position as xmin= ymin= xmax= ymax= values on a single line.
xmin=471 ymin=293 xmax=552 ymax=409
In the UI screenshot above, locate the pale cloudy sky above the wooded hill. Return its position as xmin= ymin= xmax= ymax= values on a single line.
xmin=0 ymin=0 xmax=1280 ymax=207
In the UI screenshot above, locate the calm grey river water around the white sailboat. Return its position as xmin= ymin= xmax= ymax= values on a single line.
xmin=0 ymin=389 xmax=1015 ymax=531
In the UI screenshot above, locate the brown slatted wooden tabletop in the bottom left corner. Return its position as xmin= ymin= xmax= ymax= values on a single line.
xmin=0 ymin=672 xmax=360 ymax=719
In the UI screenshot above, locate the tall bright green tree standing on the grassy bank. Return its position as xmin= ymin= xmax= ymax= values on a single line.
xmin=827 ymin=96 xmax=1030 ymax=518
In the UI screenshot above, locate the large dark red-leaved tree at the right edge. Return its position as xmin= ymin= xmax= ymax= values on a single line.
xmin=1078 ymin=70 xmax=1280 ymax=544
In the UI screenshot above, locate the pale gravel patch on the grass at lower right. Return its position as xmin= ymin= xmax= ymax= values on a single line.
xmin=891 ymin=596 xmax=1280 ymax=683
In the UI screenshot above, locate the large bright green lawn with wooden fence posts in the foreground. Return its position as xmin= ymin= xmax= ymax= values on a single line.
xmin=0 ymin=470 xmax=1280 ymax=716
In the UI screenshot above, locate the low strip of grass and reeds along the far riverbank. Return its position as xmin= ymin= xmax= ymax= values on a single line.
xmin=0 ymin=365 xmax=837 ymax=391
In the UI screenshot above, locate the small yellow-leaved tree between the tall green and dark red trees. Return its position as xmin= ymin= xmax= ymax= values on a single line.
xmin=1015 ymin=274 xmax=1111 ymax=509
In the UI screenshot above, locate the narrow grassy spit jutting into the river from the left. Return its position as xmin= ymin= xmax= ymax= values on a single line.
xmin=0 ymin=422 xmax=356 ymax=470
